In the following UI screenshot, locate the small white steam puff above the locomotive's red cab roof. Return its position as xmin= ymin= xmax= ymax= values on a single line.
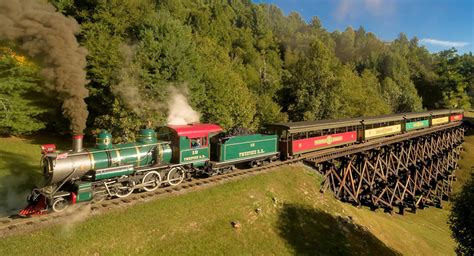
xmin=168 ymin=87 xmax=200 ymax=125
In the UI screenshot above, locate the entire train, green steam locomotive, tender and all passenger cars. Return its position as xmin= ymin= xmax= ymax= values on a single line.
xmin=19 ymin=109 xmax=464 ymax=216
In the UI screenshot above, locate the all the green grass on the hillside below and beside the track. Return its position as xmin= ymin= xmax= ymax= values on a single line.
xmin=0 ymin=125 xmax=474 ymax=255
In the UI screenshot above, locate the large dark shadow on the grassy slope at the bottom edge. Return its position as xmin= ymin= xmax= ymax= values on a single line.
xmin=277 ymin=204 xmax=400 ymax=255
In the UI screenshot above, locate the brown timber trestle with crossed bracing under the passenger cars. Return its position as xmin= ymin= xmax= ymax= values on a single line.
xmin=309 ymin=127 xmax=464 ymax=212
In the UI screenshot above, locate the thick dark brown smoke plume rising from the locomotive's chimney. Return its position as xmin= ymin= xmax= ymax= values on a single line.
xmin=0 ymin=0 xmax=89 ymax=134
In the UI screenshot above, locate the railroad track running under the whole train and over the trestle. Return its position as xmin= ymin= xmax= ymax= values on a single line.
xmin=0 ymin=123 xmax=460 ymax=237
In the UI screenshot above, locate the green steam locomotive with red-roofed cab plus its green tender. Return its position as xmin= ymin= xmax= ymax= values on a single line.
xmin=20 ymin=124 xmax=278 ymax=215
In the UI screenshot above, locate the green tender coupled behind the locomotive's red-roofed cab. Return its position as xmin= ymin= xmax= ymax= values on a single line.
xmin=211 ymin=134 xmax=278 ymax=162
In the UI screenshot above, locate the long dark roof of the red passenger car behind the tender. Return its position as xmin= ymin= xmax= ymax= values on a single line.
xmin=266 ymin=118 xmax=361 ymax=133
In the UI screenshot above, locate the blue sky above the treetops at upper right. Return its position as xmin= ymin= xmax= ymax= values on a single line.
xmin=253 ymin=0 xmax=474 ymax=54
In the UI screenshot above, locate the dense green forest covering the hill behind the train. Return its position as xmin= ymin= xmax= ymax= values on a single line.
xmin=0 ymin=0 xmax=474 ymax=141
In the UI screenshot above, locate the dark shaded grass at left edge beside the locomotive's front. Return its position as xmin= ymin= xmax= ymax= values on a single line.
xmin=0 ymin=150 xmax=43 ymax=216
